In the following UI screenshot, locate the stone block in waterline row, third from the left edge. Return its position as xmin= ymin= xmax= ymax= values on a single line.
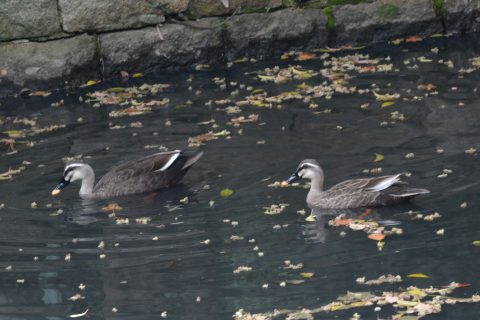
xmin=225 ymin=9 xmax=328 ymax=59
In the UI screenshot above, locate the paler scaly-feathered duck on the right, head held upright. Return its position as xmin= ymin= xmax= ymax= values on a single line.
xmin=287 ymin=159 xmax=430 ymax=209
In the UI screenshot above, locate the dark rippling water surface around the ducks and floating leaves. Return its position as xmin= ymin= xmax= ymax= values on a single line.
xmin=0 ymin=33 xmax=480 ymax=320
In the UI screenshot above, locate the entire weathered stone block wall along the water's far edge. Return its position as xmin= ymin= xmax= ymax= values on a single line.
xmin=0 ymin=0 xmax=480 ymax=91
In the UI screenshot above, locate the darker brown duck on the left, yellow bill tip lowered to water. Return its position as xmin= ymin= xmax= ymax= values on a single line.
xmin=52 ymin=150 xmax=203 ymax=199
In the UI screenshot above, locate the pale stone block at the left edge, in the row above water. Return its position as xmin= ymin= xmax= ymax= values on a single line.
xmin=0 ymin=35 xmax=97 ymax=87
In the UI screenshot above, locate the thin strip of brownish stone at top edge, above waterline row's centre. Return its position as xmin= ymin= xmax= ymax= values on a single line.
xmin=188 ymin=0 xmax=282 ymax=18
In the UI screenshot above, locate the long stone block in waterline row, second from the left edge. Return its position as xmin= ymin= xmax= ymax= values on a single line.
xmin=100 ymin=18 xmax=222 ymax=75
